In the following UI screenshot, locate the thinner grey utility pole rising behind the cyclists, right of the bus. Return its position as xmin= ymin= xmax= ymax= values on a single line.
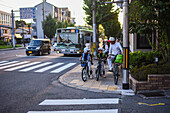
xmin=92 ymin=0 xmax=97 ymax=56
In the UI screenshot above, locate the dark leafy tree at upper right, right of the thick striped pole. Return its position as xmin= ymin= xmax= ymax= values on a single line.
xmin=129 ymin=0 xmax=170 ymax=60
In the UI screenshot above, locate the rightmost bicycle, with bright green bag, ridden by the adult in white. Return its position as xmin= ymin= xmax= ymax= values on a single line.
xmin=111 ymin=55 xmax=122 ymax=85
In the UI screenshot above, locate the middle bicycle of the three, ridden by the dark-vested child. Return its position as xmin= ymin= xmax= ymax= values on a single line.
xmin=95 ymin=60 xmax=105 ymax=81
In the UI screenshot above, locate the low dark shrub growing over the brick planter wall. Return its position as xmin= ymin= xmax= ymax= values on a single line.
xmin=131 ymin=62 xmax=170 ymax=81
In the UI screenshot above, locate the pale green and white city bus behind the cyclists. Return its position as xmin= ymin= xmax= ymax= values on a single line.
xmin=55 ymin=27 xmax=93 ymax=55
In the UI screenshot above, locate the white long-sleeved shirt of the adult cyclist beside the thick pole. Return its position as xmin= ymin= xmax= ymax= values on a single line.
xmin=109 ymin=42 xmax=123 ymax=55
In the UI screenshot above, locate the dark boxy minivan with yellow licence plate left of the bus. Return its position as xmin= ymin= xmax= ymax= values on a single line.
xmin=26 ymin=39 xmax=51 ymax=56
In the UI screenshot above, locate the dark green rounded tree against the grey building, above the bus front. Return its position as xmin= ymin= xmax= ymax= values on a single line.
xmin=42 ymin=14 xmax=56 ymax=39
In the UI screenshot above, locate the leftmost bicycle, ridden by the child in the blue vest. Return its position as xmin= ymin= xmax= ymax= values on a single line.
xmin=81 ymin=61 xmax=90 ymax=82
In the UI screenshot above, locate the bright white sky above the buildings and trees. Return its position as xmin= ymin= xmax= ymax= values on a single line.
xmin=0 ymin=0 xmax=85 ymax=25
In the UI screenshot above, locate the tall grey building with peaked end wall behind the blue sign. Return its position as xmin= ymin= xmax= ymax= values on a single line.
xmin=32 ymin=1 xmax=71 ymax=38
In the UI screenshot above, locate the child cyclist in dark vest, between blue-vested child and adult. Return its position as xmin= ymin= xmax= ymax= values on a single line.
xmin=97 ymin=48 xmax=106 ymax=78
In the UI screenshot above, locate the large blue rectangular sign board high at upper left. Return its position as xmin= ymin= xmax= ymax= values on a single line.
xmin=20 ymin=7 xmax=36 ymax=19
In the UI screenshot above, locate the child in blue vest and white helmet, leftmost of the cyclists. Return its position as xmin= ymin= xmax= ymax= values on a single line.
xmin=80 ymin=47 xmax=93 ymax=79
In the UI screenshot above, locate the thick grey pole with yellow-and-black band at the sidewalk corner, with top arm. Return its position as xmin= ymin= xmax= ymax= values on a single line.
xmin=100 ymin=0 xmax=129 ymax=89
